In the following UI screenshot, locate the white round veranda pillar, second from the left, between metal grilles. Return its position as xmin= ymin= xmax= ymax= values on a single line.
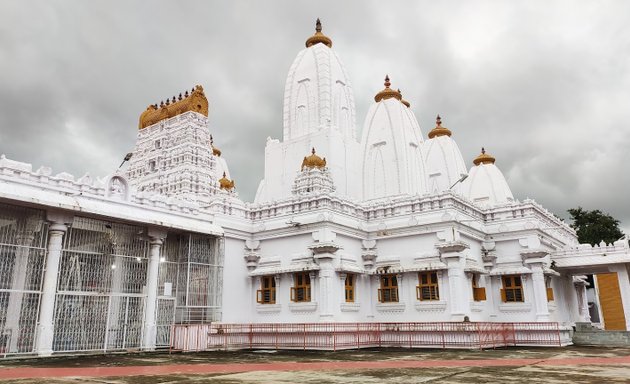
xmin=142 ymin=229 xmax=166 ymax=350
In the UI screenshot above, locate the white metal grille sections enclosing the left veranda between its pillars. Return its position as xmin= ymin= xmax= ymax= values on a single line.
xmin=0 ymin=204 xmax=223 ymax=356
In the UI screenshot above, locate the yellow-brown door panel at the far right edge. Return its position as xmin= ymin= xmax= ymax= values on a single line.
xmin=597 ymin=272 xmax=626 ymax=331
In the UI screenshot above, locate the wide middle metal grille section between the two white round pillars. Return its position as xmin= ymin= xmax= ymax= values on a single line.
xmin=53 ymin=217 xmax=148 ymax=352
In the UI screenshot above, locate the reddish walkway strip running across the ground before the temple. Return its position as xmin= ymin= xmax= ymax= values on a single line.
xmin=0 ymin=356 xmax=630 ymax=380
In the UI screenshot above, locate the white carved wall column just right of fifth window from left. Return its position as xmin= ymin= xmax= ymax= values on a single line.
xmin=442 ymin=241 xmax=472 ymax=321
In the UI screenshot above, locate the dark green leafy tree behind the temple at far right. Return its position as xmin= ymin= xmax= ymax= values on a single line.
xmin=568 ymin=207 xmax=623 ymax=245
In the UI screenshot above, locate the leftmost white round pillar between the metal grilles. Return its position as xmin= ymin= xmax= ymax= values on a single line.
xmin=35 ymin=212 xmax=73 ymax=356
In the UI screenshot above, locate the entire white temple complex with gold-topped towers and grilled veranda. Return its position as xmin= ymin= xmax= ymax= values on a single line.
xmin=0 ymin=20 xmax=630 ymax=356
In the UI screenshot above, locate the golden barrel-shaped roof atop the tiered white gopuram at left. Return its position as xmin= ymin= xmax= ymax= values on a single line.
xmin=138 ymin=85 xmax=208 ymax=129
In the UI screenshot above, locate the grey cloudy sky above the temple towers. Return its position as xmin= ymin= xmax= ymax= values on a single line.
xmin=0 ymin=0 xmax=630 ymax=233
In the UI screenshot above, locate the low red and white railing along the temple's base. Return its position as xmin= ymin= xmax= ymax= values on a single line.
xmin=171 ymin=322 xmax=562 ymax=351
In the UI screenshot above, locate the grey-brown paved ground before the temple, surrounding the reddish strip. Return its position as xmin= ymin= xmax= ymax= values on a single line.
xmin=0 ymin=346 xmax=630 ymax=384
